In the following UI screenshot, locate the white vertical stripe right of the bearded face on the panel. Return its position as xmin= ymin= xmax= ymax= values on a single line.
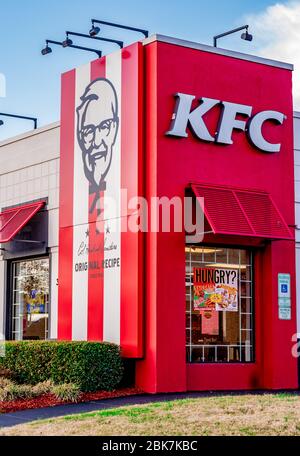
xmin=103 ymin=51 xmax=122 ymax=344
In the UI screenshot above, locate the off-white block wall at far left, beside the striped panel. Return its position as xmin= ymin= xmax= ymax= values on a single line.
xmin=0 ymin=123 xmax=60 ymax=338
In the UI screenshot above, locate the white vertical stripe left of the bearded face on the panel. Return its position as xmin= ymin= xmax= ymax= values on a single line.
xmin=72 ymin=64 xmax=91 ymax=340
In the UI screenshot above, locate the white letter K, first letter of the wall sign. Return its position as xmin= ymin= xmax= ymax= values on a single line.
xmin=166 ymin=93 xmax=220 ymax=142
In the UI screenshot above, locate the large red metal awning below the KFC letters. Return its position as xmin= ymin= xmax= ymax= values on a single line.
xmin=191 ymin=184 xmax=293 ymax=239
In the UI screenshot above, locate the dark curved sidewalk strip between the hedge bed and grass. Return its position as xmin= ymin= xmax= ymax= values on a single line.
xmin=0 ymin=390 xmax=300 ymax=427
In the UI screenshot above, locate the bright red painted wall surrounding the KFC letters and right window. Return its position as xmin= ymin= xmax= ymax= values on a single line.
xmin=136 ymin=42 xmax=297 ymax=392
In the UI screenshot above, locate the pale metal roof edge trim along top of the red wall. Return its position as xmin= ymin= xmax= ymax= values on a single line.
xmin=143 ymin=34 xmax=294 ymax=71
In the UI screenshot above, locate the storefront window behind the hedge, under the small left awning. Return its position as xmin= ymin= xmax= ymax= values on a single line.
xmin=12 ymin=258 xmax=49 ymax=340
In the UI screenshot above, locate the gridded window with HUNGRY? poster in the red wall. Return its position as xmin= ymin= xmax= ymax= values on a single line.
xmin=185 ymin=246 xmax=254 ymax=363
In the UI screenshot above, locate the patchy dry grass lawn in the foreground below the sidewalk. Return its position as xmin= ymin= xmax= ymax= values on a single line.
xmin=0 ymin=393 xmax=300 ymax=436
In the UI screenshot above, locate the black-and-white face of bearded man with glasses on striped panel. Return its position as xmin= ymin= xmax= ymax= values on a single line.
xmin=77 ymin=78 xmax=119 ymax=211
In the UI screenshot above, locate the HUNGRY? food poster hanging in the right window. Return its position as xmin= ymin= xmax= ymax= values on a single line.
xmin=193 ymin=268 xmax=238 ymax=312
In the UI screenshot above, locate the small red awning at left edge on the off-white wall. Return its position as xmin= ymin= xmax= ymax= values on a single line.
xmin=0 ymin=201 xmax=45 ymax=244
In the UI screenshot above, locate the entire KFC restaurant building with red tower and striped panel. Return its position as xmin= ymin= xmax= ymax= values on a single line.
xmin=0 ymin=35 xmax=300 ymax=393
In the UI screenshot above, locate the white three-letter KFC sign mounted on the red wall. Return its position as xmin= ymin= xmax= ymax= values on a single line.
xmin=166 ymin=93 xmax=286 ymax=152
